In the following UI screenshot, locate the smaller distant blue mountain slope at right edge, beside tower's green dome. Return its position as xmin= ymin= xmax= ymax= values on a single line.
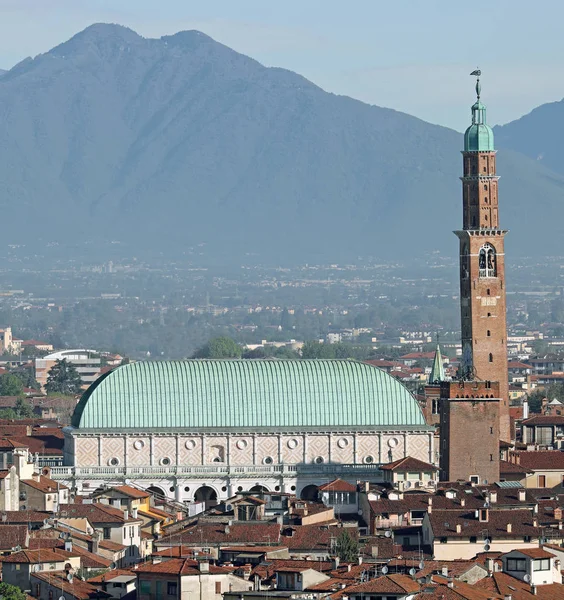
xmin=494 ymin=100 xmax=564 ymax=174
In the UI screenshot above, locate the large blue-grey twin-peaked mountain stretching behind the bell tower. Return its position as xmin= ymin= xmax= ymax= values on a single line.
xmin=0 ymin=24 xmax=564 ymax=263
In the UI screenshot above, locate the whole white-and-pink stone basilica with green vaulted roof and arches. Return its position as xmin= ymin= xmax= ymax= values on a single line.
xmin=51 ymin=360 xmax=437 ymax=502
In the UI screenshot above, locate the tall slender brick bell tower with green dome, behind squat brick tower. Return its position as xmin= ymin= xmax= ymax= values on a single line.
xmin=455 ymin=71 xmax=511 ymax=441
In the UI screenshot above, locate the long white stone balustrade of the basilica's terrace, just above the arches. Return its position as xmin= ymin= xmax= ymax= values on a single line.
xmin=51 ymin=464 xmax=380 ymax=480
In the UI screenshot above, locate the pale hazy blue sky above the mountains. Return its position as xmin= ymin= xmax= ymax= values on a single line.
xmin=0 ymin=0 xmax=564 ymax=130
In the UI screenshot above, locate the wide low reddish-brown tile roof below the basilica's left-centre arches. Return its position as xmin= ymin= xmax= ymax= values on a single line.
xmin=157 ymin=522 xmax=280 ymax=547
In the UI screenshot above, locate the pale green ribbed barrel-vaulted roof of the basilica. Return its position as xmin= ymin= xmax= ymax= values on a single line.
xmin=72 ymin=360 xmax=425 ymax=430
